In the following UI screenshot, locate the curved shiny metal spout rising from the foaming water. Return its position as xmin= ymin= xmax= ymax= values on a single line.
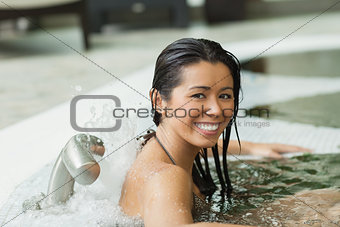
xmin=47 ymin=134 xmax=105 ymax=205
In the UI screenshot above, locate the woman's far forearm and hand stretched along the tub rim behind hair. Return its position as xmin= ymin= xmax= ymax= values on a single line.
xmin=208 ymin=139 xmax=312 ymax=158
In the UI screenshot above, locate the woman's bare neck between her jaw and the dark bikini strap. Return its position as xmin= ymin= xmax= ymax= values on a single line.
xmin=156 ymin=124 xmax=200 ymax=175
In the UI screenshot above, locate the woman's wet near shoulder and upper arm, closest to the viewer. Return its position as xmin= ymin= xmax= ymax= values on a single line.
xmin=142 ymin=165 xmax=251 ymax=227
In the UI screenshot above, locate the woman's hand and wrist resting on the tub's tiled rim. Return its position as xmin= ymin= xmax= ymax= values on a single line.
xmin=238 ymin=141 xmax=312 ymax=159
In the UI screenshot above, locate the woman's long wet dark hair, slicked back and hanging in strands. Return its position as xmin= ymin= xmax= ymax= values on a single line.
xmin=145 ymin=38 xmax=241 ymax=198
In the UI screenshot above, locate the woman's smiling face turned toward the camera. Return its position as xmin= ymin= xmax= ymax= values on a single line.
xmin=161 ymin=61 xmax=234 ymax=147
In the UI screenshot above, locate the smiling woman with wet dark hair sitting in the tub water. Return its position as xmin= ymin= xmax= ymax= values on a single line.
xmin=119 ymin=39 xmax=310 ymax=226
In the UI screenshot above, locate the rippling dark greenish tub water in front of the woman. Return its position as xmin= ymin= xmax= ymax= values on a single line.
xmin=201 ymin=154 xmax=340 ymax=226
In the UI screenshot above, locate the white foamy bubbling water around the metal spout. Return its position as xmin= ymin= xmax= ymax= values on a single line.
xmin=0 ymin=102 xmax=147 ymax=227
